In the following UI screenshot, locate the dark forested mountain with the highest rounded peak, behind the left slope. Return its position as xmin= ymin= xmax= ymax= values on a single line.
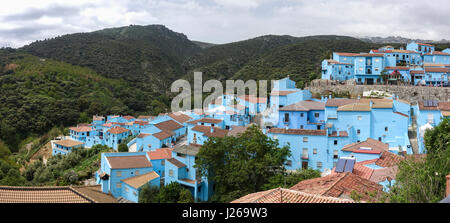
xmin=22 ymin=25 xmax=201 ymax=91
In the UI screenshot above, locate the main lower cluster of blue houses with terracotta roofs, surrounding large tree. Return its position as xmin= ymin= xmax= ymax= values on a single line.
xmin=21 ymin=72 xmax=442 ymax=202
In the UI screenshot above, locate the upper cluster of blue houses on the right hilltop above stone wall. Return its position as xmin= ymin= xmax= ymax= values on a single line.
xmin=322 ymin=42 xmax=450 ymax=86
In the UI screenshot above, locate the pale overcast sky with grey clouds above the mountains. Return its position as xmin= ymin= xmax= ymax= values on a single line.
xmin=0 ymin=0 xmax=450 ymax=47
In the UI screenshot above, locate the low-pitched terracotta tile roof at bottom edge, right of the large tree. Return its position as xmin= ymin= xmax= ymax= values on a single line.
xmin=231 ymin=188 xmax=353 ymax=203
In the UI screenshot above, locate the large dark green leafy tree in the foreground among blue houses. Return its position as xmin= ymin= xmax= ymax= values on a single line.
xmin=195 ymin=125 xmax=290 ymax=202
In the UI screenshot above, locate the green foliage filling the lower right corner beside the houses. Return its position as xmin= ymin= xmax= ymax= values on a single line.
xmin=389 ymin=118 xmax=450 ymax=203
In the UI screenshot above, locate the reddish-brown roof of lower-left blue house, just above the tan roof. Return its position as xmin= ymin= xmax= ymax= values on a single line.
xmin=106 ymin=155 xmax=152 ymax=169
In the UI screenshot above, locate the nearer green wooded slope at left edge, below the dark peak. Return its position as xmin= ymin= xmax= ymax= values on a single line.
xmin=0 ymin=50 xmax=168 ymax=150
